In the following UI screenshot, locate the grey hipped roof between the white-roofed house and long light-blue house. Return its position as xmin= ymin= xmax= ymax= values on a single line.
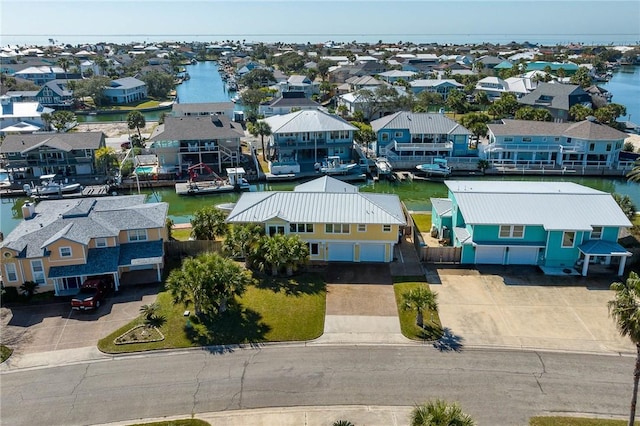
xmin=371 ymin=111 xmax=471 ymax=135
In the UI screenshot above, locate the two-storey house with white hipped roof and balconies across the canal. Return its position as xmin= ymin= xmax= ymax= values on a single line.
xmin=264 ymin=109 xmax=358 ymax=174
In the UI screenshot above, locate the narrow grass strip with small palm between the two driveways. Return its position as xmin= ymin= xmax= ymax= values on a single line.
xmin=393 ymin=277 xmax=442 ymax=340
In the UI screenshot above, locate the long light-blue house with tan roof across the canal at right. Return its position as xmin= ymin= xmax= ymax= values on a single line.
xmin=480 ymin=118 xmax=630 ymax=169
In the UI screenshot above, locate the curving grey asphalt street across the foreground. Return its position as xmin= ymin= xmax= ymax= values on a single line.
xmin=0 ymin=345 xmax=634 ymax=425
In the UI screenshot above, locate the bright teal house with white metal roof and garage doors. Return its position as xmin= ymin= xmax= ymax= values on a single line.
xmin=431 ymin=181 xmax=631 ymax=276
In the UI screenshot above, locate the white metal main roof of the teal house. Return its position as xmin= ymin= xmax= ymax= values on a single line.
xmin=445 ymin=181 xmax=631 ymax=231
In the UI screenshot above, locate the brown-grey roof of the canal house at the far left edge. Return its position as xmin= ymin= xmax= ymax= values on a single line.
xmin=0 ymin=132 xmax=104 ymax=152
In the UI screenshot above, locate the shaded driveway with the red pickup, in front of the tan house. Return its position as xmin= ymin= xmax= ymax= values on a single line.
xmin=0 ymin=284 xmax=159 ymax=358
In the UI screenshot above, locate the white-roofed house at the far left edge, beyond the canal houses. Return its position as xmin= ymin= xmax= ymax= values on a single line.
xmin=0 ymin=95 xmax=54 ymax=135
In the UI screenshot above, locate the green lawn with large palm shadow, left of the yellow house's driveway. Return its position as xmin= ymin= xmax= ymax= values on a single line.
xmin=98 ymin=274 xmax=325 ymax=353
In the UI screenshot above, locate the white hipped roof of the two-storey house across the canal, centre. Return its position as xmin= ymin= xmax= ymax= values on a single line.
xmin=264 ymin=110 xmax=358 ymax=133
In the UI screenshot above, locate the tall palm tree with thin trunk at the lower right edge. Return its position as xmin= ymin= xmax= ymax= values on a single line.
xmin=608 ymin=272 xmax=640 ymax=426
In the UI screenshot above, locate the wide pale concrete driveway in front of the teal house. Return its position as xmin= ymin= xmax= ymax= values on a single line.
xmin=427 ymin=267 xmax=635 ymax=353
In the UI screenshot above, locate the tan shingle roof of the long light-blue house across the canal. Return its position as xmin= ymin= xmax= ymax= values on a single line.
xmin=487 ymin=119 xmax=627 ymax=141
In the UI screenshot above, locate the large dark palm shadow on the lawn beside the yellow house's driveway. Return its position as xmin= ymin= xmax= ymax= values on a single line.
xmin=185 ymin=305 xmax=271 ymax=346
